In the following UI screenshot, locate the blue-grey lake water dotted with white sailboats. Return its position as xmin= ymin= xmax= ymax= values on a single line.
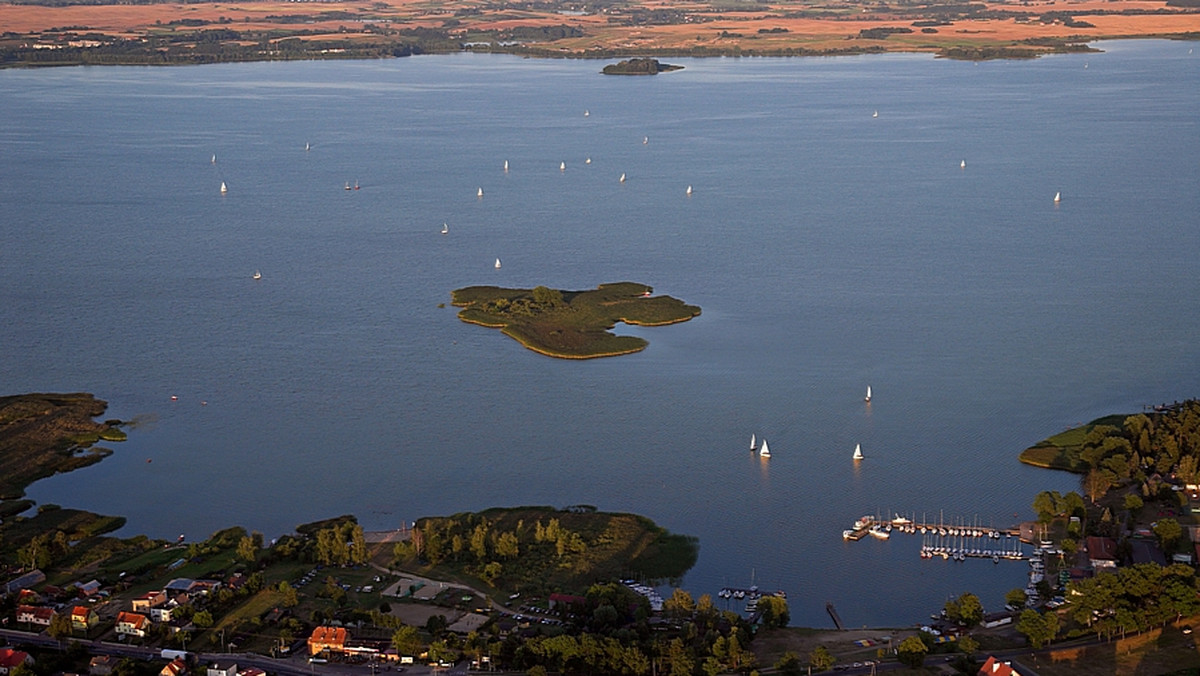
xmin=0 ymin=41 xmax=1200 ymax=627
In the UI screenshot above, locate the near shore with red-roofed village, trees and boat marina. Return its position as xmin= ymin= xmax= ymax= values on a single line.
xmin=0 ymin=402 xmax=1200 ymax=676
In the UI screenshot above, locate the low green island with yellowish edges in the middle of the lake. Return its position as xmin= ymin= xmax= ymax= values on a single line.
xmin=451 ymin=282 xmax=700 ymax=359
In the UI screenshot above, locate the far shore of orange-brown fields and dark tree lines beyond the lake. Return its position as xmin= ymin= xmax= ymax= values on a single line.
xmin=0 ymin=0 xmax=1200 ymax=67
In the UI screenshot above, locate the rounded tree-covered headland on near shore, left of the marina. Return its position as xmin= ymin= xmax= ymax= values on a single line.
xmin=395 ymin=507 xmax=698 ymax=596
